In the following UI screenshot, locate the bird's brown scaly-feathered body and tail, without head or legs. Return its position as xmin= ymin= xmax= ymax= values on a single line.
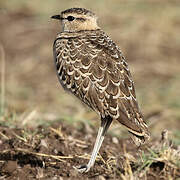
xmin=53 ymin=30 xmax=149 ymax=144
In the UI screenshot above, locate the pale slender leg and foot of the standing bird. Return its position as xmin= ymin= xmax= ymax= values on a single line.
xmin=77 ymin=119 xmax=112 ymax=173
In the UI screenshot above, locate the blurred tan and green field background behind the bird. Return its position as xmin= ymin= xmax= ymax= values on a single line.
xmin=0 ymin=0 xmax=180 ymax=140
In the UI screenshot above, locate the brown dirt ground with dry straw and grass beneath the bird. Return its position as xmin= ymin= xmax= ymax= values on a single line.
xmin=0 ymin=123 xmax=180 ymax=180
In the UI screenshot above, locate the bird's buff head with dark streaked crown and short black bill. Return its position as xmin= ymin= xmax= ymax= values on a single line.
xmin=51 ymin=8 xmax=99 ymax=32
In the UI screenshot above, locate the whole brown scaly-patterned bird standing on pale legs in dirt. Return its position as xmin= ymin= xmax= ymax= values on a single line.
xmin=51 ymin=7 xmax=150 ymax=173
